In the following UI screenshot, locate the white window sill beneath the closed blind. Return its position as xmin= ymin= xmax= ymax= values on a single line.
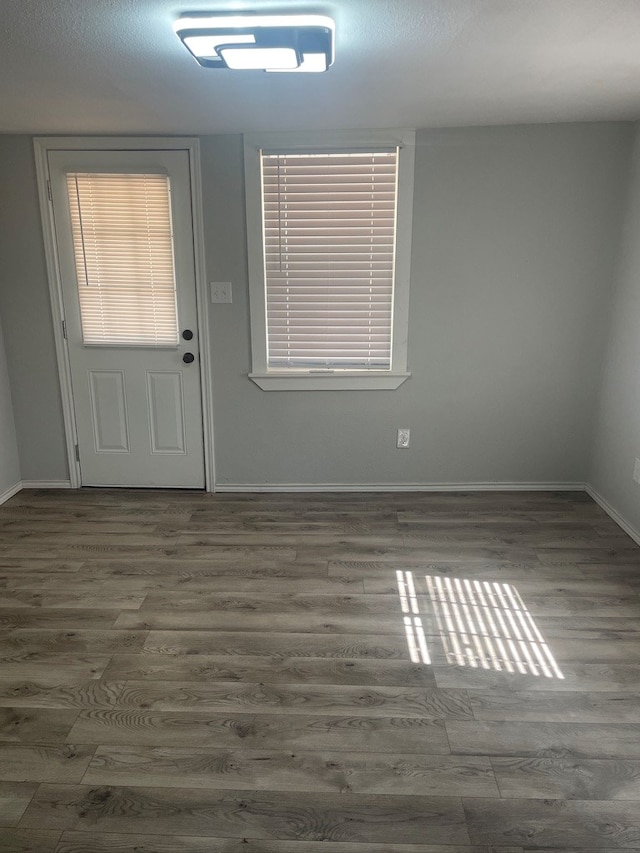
xmin=249 ymin=370 xmax=411 ymax=391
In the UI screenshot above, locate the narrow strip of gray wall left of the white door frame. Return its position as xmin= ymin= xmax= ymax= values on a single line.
xmin=0 ymin=136 xmax=69 ymax=480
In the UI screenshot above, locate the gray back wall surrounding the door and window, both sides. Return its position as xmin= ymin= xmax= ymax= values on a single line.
xmin=0 ymin=123 xmax=632 ymax=484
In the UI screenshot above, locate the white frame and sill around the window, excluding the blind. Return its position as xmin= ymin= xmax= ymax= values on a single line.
xmin=244 ymin=130 xmax=415 ymax=391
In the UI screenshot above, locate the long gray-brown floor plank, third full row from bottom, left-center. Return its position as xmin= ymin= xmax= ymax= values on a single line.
xmin=66 ymin=710 xmax=450 ymax=755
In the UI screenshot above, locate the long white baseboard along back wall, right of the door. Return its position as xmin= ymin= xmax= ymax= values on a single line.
xmin=215 ymin=482 xmax=585 ymax=492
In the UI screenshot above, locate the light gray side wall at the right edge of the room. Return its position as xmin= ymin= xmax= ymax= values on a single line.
xmin=589 ymin=121 xmax=640 ymax=531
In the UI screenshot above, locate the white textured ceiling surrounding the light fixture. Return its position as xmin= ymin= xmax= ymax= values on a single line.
xmin=0 ymin=0 xmax=640 ymax=134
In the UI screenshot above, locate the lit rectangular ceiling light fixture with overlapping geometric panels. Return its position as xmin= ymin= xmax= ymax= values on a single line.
xmin=173 ymin=13 xmax=335 ymax=72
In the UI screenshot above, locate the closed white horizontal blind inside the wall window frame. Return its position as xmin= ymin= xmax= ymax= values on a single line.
xmin=262 ymin=149 xmax=398 ymax=370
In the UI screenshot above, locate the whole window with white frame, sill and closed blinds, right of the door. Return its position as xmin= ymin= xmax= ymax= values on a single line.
xmin=245 ymin=132 xmax=414 ymax=390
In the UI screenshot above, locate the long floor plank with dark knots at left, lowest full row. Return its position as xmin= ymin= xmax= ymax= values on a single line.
xmin=21 ymin=784 xmax=469 ymax=844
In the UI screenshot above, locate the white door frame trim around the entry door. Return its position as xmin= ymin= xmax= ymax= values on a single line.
xmin=33 ymin=136 xmax=215 ymax=492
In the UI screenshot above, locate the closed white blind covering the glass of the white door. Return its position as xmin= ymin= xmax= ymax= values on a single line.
xmin=67 ymin=172 xmax=178 ymax=346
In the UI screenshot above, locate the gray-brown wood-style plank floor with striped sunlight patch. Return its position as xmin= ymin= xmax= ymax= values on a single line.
xmin=0 ymin=490 xmax=640 ymax=853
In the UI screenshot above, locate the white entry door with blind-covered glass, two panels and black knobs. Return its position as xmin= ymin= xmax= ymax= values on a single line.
xmin=48 ymin=150 xmax=205 ymax=488
